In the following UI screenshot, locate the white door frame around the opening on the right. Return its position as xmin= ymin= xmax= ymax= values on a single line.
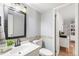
xmin=53 ymin=3 xmax=79 ymax=56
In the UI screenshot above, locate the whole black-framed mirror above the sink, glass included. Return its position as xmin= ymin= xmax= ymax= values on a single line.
xmin=4 ymin=6 xmax=26 ymax=39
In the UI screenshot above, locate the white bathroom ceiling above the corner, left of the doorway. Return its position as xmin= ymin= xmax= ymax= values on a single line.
xmin=28 ymin=3 xmax=64 ymax=13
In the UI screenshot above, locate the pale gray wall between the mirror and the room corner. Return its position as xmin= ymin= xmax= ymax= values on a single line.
xmin=26 ymin=6 xmax=41 ymax=37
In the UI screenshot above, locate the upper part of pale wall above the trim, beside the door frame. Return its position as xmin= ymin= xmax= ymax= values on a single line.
xmin=41 ymin=11 xmax=53 ymax=36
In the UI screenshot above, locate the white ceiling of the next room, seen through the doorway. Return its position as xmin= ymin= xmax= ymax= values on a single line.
xmin=59 ymin=4 xmax=75 ymax=20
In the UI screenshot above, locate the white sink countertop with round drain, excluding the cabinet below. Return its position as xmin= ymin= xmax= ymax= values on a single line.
xmin=3 ymin=42 xmax=40 ymax=56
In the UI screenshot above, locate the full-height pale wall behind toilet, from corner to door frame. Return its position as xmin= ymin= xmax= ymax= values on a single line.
xmin=41 ymin=10 xmax=55 ymax=53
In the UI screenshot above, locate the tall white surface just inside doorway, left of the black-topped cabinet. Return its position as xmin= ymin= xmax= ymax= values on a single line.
xmin=55 ymin=11 xmax=63 ymax=55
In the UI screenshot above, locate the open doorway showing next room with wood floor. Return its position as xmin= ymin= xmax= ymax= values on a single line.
xmin=55 ymin=3 xmax=76 ymax=56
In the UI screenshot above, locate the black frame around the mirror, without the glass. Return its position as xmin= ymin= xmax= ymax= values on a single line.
xmin=4 ymin=6 xmax=26 ymax=39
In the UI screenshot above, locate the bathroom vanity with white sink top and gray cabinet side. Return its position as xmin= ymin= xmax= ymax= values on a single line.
xmin=1 ymin=42 xmax=40 ymax=56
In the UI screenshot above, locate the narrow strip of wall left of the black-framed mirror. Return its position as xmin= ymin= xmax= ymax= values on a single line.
xmin=0 ymin=4 xmax=6 ymax=47
